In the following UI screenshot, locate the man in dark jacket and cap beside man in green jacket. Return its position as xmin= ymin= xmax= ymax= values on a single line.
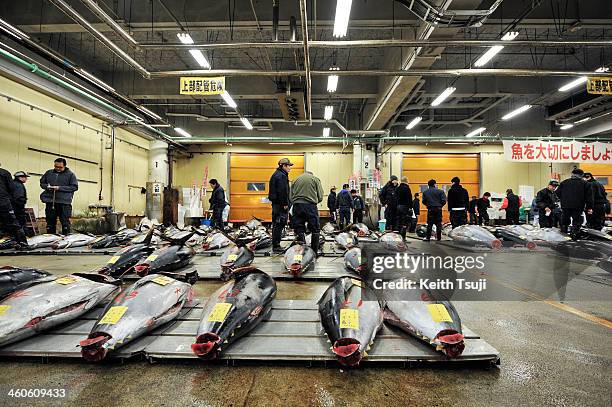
xmin=268 ymin=158 xmax=293 ymax=253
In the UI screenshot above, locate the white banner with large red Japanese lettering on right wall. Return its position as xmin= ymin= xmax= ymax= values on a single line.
xmin=503 ymin=140 xmax=612 ymax=164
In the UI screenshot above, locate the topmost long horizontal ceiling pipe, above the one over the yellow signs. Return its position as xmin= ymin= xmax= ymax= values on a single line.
xmin=140 ymin=39 xmax=612 ymax=51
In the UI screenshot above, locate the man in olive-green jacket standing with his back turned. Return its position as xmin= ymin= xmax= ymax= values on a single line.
xmin=291 ymin=171 xmax=323 ymax=254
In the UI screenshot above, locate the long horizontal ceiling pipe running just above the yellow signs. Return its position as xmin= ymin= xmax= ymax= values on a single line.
xmin=149 ymin=68 xmax=612 ymax=79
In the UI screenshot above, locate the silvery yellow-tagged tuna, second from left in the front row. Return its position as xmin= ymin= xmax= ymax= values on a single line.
xmin=79 ymin=274 xmax=193 ymax=362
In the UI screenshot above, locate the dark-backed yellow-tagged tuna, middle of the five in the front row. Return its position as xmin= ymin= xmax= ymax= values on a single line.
xmin=191 ymin=267 xmax=276 ymax=359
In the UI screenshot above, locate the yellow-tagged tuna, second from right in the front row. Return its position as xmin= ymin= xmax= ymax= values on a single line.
xmin=319 ymin=277 xmax=383 ymax=366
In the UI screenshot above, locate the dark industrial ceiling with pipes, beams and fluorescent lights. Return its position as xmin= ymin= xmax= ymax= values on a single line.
xmin=0 ymin=0 xmax=612 ymax=143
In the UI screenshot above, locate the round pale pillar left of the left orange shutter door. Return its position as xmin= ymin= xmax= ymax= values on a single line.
xmin=146 ymin=140 xmax=168 ymax=223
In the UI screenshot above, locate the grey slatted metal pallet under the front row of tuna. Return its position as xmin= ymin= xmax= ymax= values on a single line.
xmin=0 ymin=300 xmax=500 ymax=363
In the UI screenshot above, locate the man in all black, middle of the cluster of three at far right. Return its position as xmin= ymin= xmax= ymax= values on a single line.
xmin=556 ymin=168 xmax=593 ymax=239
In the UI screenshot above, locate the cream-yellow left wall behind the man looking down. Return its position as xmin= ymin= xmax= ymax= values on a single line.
xmin=0 ymin=76 xmax=149 ymax=216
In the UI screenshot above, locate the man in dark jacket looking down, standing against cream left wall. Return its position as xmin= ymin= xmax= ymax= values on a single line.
xmin=40 ymin=158 xmax=79 ymax=235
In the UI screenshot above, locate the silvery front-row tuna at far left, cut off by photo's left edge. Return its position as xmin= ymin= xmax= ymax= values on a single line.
xmin=0 ymin=273 xmax=121 ymax=346
